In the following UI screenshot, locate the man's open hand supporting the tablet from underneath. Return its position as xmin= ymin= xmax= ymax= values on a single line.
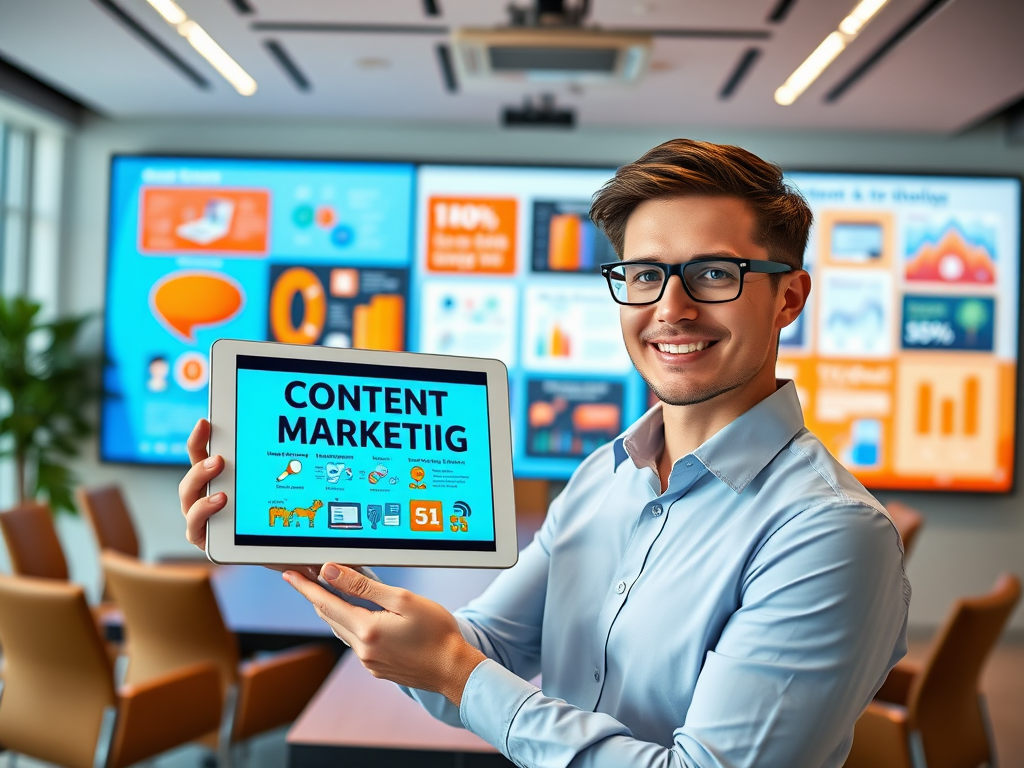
xmin=285 ymin=563 xmax=486 ymax=707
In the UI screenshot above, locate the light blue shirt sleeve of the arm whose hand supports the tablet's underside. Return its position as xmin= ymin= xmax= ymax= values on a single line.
xmin=461 ymin=504 xmax=909 ymax=768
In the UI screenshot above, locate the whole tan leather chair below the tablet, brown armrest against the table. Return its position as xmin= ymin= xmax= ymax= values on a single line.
xmin=102 ymin=551 xmax=336 ymax=765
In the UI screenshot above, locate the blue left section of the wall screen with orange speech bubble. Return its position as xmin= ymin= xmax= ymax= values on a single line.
xmin=100 ymin=157 xmax=415 ymax=463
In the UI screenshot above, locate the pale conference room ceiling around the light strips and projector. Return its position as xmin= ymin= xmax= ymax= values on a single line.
xmin=0 ymin=0 xmax=1024 ymax=134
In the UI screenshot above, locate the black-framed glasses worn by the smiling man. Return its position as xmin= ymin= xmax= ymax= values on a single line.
xmin=601 ymin=256 xmax=793 ymax=306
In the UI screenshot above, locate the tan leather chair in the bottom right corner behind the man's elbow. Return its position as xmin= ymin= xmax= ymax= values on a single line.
xmin=846 ymin=573 xmax=1021 ymax=768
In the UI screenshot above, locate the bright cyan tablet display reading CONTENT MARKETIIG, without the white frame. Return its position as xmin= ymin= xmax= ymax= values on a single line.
xmin=234 ymin=355 xmax=495 ymax=552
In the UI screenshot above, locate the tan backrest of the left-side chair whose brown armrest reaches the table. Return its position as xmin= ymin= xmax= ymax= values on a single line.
xmin=101 ymin=551 xmax=239 ymax=692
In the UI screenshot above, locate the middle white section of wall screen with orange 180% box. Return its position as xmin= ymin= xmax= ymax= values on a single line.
xmin=412 ymin=165 xmax=646 ymax=477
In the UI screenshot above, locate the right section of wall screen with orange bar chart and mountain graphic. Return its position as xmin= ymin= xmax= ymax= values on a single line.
xmin=779 ymin=173 xmax=1021 ymax=492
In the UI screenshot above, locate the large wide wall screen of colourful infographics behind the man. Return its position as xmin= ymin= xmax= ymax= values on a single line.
xmin=100 ymin=156 xmax=1021 ymax=492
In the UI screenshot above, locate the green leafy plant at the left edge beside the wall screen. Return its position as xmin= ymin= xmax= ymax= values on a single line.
xmin=0 ymin=296 xmax=97 ymax=513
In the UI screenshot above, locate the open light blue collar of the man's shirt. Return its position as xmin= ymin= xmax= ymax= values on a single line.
xmin=613 ymin=379 xmax=804 ymax=494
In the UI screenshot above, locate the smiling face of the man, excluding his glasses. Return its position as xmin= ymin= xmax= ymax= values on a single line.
xmin=620 ymin=196 xmax=809 ymax=406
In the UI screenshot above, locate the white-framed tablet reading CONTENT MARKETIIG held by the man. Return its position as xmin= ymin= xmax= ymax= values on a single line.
xmin=206 ymin=339 xmax=518 ymax=568
